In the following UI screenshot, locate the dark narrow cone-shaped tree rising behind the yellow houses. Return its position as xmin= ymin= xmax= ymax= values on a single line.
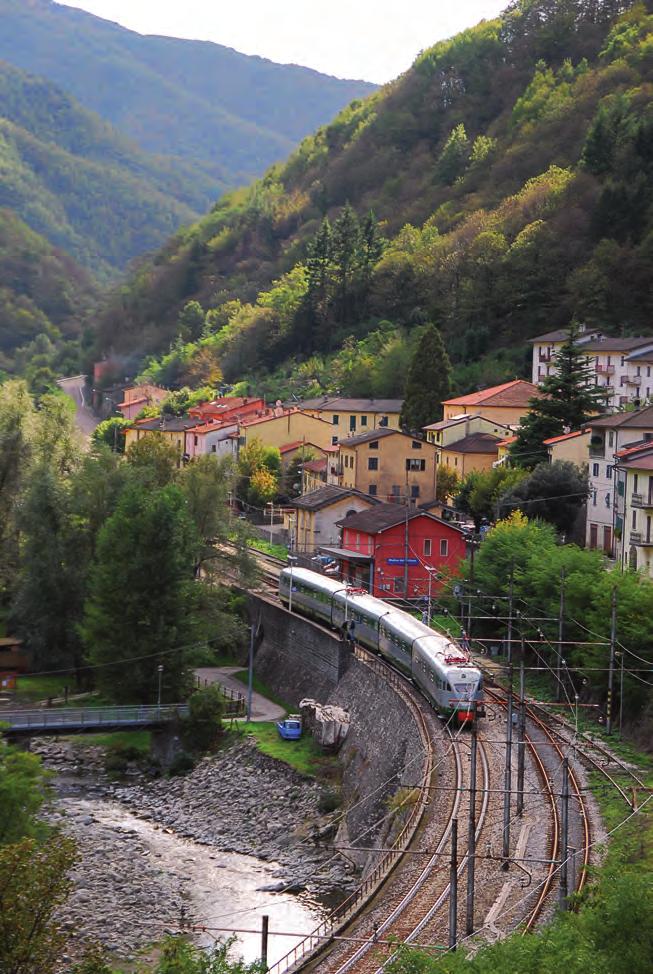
xmin=401 ymin=325 xmax=451 ymax=433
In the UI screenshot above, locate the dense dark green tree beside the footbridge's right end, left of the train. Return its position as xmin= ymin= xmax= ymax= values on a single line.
xmin=81 ymin=485 xmax=199 ymax=703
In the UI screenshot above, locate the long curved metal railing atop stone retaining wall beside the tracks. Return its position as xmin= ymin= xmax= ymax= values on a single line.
xmin=268 ymin=646 xmax=433 ymax=974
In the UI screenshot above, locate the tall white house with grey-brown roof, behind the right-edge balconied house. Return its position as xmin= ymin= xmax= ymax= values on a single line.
xmin=585 ymin=406 xmax=653 ymax=556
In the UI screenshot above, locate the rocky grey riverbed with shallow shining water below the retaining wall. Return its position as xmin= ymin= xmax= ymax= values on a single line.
xmin=34 ymin=739 xmax=355 ymax=961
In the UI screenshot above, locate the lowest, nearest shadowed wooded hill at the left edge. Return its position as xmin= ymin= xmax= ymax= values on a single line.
xmin=0 ymin=209 xmax=98 ymax=384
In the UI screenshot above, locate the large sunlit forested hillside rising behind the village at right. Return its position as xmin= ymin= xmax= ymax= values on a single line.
xmin=94 ymin=0 xmax=653 ymax=395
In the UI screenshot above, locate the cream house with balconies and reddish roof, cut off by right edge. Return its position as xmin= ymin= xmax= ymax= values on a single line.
xmin=615 ymin=440 xmax=653 ymax=578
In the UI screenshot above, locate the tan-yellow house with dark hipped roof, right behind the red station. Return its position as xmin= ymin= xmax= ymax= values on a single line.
xmin=339 ymin=428 xmax=436 ymax=503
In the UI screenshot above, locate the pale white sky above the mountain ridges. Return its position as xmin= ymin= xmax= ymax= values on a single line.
xmin=58 ymin=0 xmax=508 ymax=83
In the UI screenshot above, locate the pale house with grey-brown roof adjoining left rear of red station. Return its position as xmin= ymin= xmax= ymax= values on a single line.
xmin=291 ymin=484 xmax=379 ymax=557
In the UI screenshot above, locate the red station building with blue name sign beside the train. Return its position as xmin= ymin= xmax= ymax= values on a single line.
xmin=320 ymin=504 xmax=466 ymax=598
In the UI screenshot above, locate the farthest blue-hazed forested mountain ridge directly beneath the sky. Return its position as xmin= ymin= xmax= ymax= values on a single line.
xmin=0 ymin=0 xmax=375 ymax=190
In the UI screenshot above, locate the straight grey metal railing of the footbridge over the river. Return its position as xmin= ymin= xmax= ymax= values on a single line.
xmin=0 ymin=703 xmax=188 ymax=731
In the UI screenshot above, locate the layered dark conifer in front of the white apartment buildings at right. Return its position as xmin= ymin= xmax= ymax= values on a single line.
xmin=510 ymin=327 xmax=606 ymax=467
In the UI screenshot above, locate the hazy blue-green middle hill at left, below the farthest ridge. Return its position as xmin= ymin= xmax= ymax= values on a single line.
xmin=0 ymin=61 xmax=232 ymax=278
